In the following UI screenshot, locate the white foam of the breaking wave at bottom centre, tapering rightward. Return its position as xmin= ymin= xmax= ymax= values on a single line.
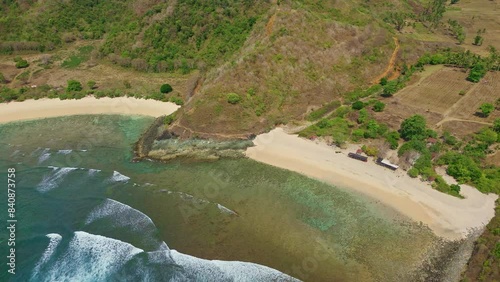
xmin=170 ymin=250 xmax=300 ymax=282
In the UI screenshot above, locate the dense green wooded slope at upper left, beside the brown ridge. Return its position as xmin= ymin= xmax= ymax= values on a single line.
xmin=0 ymin=0 xmax=270 ymax=73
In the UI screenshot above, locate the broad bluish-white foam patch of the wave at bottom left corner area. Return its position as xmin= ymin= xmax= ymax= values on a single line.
xmin=32 ymin=231 xmax=143 ymax=281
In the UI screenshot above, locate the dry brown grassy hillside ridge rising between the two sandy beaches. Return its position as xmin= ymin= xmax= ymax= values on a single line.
xmin=169 ymin=3 xmax=450 ymax=137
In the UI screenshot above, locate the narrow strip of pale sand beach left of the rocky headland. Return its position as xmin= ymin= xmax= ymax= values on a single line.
xmin=0 ymin=97 xmax=179 ymax=123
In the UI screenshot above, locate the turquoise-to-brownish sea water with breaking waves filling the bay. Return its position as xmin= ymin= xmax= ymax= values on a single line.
xmin=0 ymin=116 xmax=435 ymax=281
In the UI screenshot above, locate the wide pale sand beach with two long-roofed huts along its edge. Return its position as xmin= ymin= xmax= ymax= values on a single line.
xmin=246 ymin=128 xmax=497 ymax=240
